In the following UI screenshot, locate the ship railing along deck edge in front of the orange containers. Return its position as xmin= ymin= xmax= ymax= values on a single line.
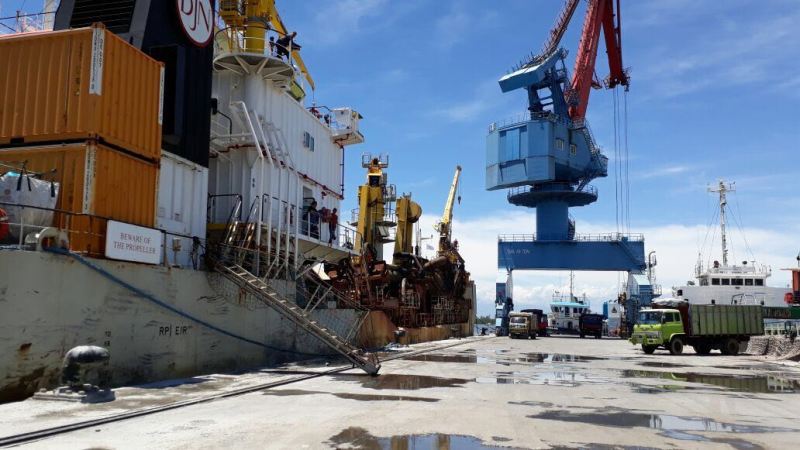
xmin=0 ymin=201 xmax=207 ymax=270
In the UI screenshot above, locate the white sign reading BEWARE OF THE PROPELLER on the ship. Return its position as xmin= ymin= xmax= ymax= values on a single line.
xmin=106 ymin=220 xmax=163 ymax=264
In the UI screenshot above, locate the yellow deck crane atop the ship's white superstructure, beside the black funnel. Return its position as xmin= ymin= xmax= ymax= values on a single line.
xmin=219 ymin=0 xmax=315 ymax=89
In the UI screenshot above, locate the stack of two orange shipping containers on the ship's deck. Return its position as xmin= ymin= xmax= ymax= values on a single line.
xmin=0 ymin=25 xmax=164 ymax=254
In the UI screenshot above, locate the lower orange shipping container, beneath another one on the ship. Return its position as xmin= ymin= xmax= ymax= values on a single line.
xmin=0 ymin=141 xmax=158 ymax=255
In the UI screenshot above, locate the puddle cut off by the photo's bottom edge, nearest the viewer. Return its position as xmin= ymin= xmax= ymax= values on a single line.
xmin=327 ymin=427 xmax=524 ymax=450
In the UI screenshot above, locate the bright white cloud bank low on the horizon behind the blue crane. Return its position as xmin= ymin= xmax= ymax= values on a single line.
xmin=420 ymin=210 xmax=800 ymax=314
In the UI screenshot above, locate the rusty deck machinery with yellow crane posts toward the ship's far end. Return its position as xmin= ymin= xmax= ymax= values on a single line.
xmin=318 ymin=156 xmax=471 ymax=327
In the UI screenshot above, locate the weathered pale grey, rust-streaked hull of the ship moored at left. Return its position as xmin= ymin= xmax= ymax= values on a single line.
xmin=0 ymin=250 xmax=471 ymax=403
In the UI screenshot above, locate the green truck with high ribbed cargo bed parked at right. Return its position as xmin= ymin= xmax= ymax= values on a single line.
xmin=630 ymin=302 xmax=764 ymax=355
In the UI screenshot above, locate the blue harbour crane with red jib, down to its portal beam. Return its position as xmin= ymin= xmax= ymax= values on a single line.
xmin=486 ymin=0 xmax=645 ymax=271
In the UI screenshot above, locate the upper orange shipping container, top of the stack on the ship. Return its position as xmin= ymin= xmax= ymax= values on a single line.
xmin=0 ymin=25 xmax=164 ymax=161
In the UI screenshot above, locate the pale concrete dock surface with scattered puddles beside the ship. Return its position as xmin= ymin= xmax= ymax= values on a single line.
xmin=0 ymin=336 xmax=800 ymax=449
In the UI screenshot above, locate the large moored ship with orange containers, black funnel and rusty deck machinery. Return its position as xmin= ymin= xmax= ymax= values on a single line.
xmin=0 ymin=0 xmax=475 ymax=402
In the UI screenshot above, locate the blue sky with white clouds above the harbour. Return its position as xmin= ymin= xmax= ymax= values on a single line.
xmin=6 ymin=0 xmax=800 ymax=313
